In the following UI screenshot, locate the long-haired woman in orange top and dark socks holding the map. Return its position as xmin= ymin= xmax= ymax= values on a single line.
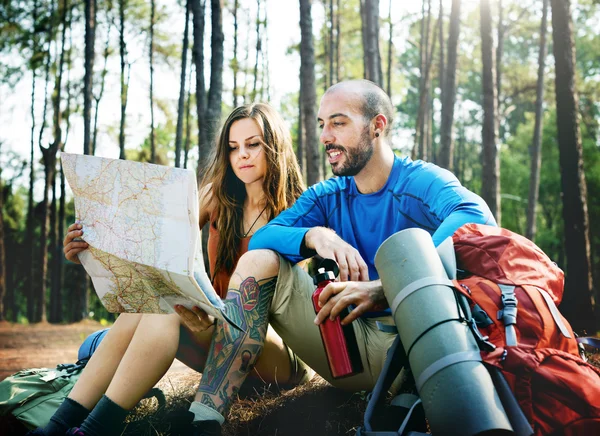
xmin=34 ymin=103 xmax=314 ymax=435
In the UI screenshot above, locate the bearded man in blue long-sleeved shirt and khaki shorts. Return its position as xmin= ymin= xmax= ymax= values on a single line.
xmin=190 ymin=80 xmax=495 ymax=434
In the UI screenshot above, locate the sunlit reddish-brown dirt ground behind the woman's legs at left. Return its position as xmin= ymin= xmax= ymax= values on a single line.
xmin=0 ymin=320 xmax=191 ymax=381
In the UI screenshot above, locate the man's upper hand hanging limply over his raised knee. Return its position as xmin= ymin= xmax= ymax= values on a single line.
xmin=304 ymin=227 xmax=369 ymax=282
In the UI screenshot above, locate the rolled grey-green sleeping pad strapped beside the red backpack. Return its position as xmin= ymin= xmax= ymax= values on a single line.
xmin=375 ymin=229 xmax=513 ymax=436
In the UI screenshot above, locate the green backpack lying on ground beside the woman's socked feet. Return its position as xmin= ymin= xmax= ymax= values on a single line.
xmin=0 ymin=363 xmax=85 ymax=430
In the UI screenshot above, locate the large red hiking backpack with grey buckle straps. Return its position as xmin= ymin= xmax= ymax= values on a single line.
xmin=453 ymin=224 xmax=600 ymax=435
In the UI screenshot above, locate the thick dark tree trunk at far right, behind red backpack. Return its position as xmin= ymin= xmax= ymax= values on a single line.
xmin=551 ymin=0 xmax=598 ymax=333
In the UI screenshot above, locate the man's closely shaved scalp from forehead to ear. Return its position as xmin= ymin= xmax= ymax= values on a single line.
xmin=325 ymin=80 xmax=394 ymax=137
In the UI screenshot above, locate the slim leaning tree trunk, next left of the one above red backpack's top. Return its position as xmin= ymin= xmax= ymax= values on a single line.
xmin=438 ymin=0 xmax=461 ymax=170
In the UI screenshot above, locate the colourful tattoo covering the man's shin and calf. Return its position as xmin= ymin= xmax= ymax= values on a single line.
xmin=198 ymin=277 xmax=277 ymax=413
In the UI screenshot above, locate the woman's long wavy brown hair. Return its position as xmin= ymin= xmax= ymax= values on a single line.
xmin=202 ymin=103 xmax=304 ymax=277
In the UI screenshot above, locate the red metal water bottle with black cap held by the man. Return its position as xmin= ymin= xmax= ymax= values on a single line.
xmin=312 ymin=259 xmax=363 ymax=378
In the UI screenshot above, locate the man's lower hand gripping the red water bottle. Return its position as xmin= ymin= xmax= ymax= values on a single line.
xmin=315 ymin=280 xmax=388 ymax=325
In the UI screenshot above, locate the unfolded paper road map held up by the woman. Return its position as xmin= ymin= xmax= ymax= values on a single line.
xmin=61 ymin=153 xmax=237 ymax=321
